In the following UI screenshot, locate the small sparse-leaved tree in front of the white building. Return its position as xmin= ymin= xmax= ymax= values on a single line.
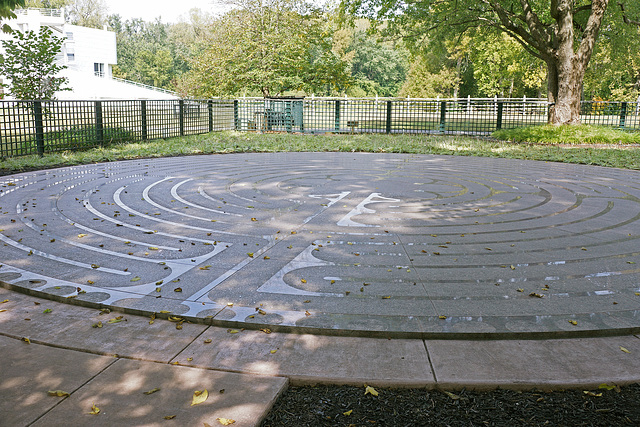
xmin=0 ymin=27 xmax=71 ymax=99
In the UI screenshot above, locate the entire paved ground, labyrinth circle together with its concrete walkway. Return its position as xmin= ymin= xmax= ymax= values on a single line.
xmin=0 ymin=153 xmax=640 ymax=425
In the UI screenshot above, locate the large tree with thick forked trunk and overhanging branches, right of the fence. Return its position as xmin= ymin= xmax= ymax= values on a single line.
xmin=342 ymin=0 xmax=625 ymax=124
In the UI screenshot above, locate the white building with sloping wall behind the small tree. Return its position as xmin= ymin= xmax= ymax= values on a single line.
xmin=0 ymin=9 xmax=177 ymax=100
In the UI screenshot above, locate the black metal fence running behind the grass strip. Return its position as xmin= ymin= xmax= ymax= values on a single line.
xmin=0 ymin=98 xmax=640 ymax=158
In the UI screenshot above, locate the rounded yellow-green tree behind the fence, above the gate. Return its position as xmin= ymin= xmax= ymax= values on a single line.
xmin=181 ymin=0 xmax=348 ymax=97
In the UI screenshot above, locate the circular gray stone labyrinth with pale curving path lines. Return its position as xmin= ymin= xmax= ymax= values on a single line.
xmin=0 ymin=153 xmax=640 ymax=337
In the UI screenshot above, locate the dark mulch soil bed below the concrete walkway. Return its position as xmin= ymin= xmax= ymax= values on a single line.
xmin=262 ymin=384 xmax=640 ymax=427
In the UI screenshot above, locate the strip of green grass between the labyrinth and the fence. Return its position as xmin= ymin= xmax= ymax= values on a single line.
xmin=0 ymin=126 xmax=640 ymax=175
